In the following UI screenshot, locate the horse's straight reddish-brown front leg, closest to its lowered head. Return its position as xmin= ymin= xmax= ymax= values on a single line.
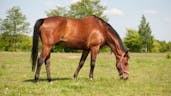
xmin=89 ymin=46 xmax=100 ymax=80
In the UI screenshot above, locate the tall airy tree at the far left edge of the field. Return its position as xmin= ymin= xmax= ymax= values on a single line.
xmin=0 ymin=6 xmax=30 ymax=51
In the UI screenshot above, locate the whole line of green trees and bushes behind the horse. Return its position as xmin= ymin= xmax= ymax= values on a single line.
xmin=0 ymin=0 xmax=171 ymax=52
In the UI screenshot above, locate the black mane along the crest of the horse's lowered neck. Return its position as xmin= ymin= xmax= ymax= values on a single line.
xmin=93 ymin=15 xmax=126 ymax=52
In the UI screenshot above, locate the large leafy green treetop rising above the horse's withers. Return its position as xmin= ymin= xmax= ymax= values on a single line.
xmin=68 ymin=0 xmax=107 ymax=20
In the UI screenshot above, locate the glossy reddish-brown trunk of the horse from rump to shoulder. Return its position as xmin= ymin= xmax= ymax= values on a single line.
xmin=39 ymin=16 xmax=104 ymax=49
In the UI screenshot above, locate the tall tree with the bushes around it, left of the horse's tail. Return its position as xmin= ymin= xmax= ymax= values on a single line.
xmin=0 ymin=6 xmax=31 ymax=51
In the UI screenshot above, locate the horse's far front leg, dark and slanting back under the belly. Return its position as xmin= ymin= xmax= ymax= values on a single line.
xmin=74 ymin=50 xmax=89 ymax=78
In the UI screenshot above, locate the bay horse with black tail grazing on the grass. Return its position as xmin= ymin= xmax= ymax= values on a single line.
xmin=31 ymin=16 xmax=129 ymax=81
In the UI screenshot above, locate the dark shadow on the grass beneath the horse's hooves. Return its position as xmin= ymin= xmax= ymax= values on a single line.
xmin=23 ymin=78 xmax=72 ymax=83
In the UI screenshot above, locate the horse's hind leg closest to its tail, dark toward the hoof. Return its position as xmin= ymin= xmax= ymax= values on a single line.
xmin=35 ymin=46 xmax=51 ymax=82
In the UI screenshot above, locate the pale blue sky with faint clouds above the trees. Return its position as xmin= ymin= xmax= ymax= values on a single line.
xmin=0 ymin=0 xmax=171 ymax=41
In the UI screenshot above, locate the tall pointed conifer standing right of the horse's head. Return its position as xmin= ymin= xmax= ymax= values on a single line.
xmin=138 ymin=15 xmax=153 ymax=52
